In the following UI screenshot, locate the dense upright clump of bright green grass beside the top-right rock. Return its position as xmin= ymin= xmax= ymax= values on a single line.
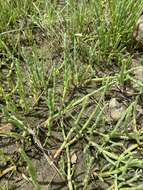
xmin=94 ymin=0 xmax=142 ymax=49
